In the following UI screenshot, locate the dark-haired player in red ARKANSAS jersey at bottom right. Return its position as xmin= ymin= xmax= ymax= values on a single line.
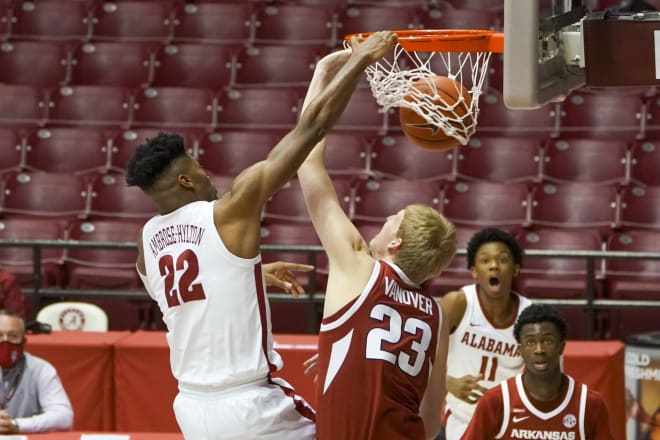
xmin=461 ymin=304 xmax=613 ymax=440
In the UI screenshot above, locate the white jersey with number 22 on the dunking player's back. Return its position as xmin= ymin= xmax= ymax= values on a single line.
xmin=142 ymin=202 xmax=282 ymax=387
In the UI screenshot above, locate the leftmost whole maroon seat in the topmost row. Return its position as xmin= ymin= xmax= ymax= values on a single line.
xmin=11 ymin=0 xmax=93 ymax=41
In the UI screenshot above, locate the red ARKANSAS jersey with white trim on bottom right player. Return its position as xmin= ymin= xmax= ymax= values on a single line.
xmin=461 ymin=374 xmax=612 ymax=440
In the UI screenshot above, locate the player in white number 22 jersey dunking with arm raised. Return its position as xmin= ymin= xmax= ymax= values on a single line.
xmin=126 ymin=31 xmax=396 ymax=440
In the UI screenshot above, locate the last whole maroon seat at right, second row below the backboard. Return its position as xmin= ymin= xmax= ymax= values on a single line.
xmin=543 ymin=138 xmax=630 ymax=185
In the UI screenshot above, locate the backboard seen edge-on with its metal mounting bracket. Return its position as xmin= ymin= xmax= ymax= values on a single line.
xmin=503 ymin=0 xmax=592 ymax=109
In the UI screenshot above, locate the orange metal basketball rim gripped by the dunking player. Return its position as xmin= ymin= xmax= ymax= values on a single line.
xmin=344 ymin=29 xmax=504 ymax=53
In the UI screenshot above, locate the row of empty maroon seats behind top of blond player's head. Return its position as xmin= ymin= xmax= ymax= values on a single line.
xmin=0 ymin=171 xmax=660 ymax=236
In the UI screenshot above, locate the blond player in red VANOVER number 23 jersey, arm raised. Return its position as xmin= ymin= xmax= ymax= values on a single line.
xmin=298 ymin=51 xmax=456 ymax=440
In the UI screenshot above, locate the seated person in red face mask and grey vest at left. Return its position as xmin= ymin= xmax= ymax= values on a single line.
xmin=0 ymin=309 xmax=73 ymax=434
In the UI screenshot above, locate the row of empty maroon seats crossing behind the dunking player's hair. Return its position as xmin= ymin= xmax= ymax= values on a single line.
xmin=6 ymin=122 xmax=660 ymax=187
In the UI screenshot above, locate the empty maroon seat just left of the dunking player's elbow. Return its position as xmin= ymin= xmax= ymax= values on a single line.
xmin=218 ymin=88 xmax=300 ymax=130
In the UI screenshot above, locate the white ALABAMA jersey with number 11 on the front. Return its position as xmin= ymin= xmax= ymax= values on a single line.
xmin=447 ymin=284 xmax=531 ymax=426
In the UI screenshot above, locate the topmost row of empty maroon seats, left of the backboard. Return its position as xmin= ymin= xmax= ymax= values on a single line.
xmin=0 ymin=0 xmax=501 ymax=47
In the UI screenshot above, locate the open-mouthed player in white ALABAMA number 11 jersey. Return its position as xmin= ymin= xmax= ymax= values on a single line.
xmin=440 ymin=228 xmax=531 ymax=440
